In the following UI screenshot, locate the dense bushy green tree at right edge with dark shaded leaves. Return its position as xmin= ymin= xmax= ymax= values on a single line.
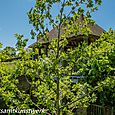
xmin=67 ymin=30 xmax=115 ymax=106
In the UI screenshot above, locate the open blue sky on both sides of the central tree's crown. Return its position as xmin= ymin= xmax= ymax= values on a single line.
xmin=0 ymin=0 xmax=115 ymax=47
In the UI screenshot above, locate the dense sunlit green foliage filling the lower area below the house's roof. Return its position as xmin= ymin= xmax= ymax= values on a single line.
xmin=0 ymin=29 xmax=115 ymax=114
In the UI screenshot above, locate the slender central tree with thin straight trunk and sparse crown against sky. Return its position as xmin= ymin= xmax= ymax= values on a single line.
xmin=28 ymin=0 xmax=101 ymax=115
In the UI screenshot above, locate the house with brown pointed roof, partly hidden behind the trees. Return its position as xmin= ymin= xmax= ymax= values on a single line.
xmin=28 ymin=15 xmax=105 ymax=58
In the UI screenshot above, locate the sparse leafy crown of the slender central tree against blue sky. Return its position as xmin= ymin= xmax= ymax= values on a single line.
xmin=28 ymin=0 xmax=101 ymax=41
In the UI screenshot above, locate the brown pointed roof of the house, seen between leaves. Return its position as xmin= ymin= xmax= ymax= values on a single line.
xmin=29 ymin=16 xmax=105 ymax=47
